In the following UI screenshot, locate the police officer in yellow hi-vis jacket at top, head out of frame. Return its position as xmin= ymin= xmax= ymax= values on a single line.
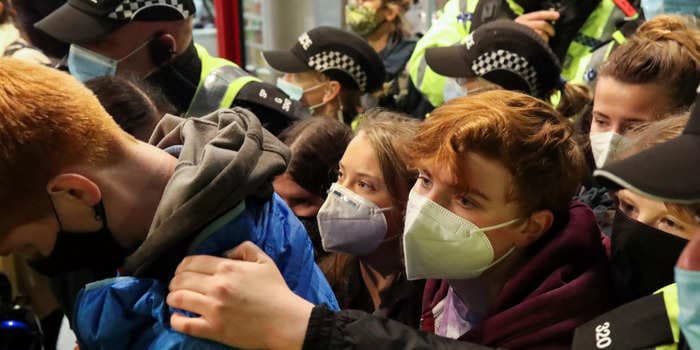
xmin=408 ymin=0 xmax=640 ymax=106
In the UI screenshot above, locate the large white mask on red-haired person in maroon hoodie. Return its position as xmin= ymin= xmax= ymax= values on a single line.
xmin=403 ymin=191 xmax=520 ymax=280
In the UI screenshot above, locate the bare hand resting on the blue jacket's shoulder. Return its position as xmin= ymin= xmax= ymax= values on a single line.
xmin=167 ymin=242 xmax=313 ymax=349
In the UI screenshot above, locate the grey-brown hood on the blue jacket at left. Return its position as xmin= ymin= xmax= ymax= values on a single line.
xmin=124 ymin=108 xmax=290 ymax=278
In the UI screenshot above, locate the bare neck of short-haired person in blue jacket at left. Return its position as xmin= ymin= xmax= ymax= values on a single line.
xmin=92 ymin=142 xmax=177 ymax=247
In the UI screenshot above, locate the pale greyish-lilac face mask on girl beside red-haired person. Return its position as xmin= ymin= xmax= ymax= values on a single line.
xmin=316 ymin=183 xmax=391 ymax=256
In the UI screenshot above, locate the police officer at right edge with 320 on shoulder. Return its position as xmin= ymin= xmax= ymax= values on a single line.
xmin=573 ymin=91 xmax=700 ymax=350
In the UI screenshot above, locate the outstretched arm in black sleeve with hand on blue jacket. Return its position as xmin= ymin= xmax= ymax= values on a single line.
xmin=167 ymin=242 xmax=498 ymax=350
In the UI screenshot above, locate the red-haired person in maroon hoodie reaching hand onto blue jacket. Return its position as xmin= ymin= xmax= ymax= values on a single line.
xmin=168 ymin=91 xmax=608 ymax=349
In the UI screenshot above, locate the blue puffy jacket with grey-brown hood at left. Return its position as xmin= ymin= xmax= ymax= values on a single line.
xmin=72 ymin=108 xmax=338 ymax=350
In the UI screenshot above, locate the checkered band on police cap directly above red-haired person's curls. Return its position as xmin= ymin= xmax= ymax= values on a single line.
xmin=472 ymin=49 xmax=539 ymax=96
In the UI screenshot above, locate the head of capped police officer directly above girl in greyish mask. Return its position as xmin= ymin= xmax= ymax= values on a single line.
xmin=263 ymin=26 xmax=385 ymax=124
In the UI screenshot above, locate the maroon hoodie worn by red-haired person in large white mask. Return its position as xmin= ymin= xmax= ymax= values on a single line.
xmin=421 ymin=202 xmax=611 ymax=349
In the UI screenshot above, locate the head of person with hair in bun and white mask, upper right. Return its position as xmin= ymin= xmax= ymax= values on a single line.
xmin=588 ymin=15 xmax=700 ymax=168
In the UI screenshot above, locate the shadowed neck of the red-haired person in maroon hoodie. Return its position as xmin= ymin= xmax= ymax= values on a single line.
xmin=448 ymin=249 xmax=523 ymax=318
